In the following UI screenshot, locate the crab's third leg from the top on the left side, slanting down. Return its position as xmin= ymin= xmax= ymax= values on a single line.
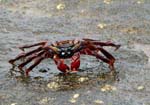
xmin=18 ymin=51 xmax=45 ymax=70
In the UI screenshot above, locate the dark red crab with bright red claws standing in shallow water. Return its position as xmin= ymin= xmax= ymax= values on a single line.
xmin=9 ymin=38 xmax=120 ymax=76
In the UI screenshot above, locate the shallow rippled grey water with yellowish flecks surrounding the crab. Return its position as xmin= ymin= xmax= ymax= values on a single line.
xmin=0 ymin=0 xmax=150 ymax=105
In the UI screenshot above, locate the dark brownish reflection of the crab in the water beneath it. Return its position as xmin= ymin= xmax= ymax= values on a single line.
xmin=11 ymin=67 xmax=118 ymax=91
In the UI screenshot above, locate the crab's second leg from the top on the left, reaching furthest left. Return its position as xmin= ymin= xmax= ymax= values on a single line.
xmin=9 ymin=47 xmax=42 ymax=64
